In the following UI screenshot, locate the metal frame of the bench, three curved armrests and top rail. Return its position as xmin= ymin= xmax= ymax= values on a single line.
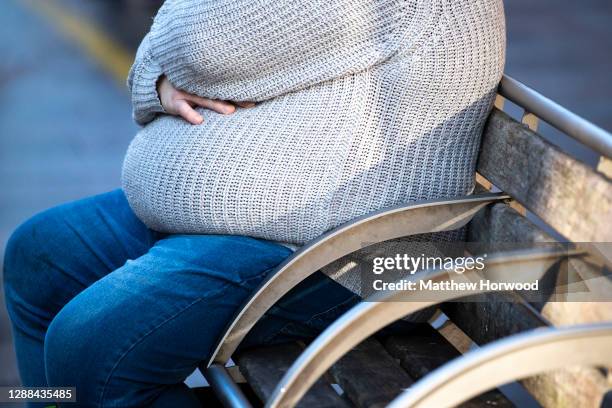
xmin=200 ymin=76 xmax=612 ymax=407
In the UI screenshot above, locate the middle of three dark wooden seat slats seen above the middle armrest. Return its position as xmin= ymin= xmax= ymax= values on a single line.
xmin=329 ymin=338 xmax=413 ymax=408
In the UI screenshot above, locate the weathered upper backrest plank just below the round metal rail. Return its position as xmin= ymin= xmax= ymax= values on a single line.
xmin=477 ymin=109 xmax=612 ymax=242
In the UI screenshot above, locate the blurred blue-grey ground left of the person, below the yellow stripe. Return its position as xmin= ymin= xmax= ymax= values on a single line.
xmin=0 ymin=0 xmax=136 ymax=384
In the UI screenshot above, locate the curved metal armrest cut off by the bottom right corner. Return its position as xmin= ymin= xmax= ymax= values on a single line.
xmin=388 ymin=322 xmax=612 ymax=408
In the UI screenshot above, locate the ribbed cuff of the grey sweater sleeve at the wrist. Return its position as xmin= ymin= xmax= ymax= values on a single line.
xmin=132 ymin=53 xmax=165 ymax=126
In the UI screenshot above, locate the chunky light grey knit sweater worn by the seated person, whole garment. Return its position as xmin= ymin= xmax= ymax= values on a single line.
xmin=123 ymin=0 xmax=505 ymax=244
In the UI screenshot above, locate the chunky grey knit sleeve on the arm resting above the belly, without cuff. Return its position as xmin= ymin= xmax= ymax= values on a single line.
xmin=147 ymin=0 xmax=424 ymax=101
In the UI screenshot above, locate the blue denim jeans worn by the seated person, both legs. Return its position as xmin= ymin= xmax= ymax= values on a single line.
xmin=4 ymin=190 xmax=358 ymax=407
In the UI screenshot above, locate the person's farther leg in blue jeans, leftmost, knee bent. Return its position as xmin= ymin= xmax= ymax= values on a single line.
xmin=2 ymin=190 xmax=161 ymax=387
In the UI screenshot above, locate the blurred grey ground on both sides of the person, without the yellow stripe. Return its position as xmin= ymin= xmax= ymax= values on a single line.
xmin=0 ymin=0 xmax=612 ymax=385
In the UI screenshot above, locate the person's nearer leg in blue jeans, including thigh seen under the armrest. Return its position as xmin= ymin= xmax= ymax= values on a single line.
xmin=45 ymin=231 xmax=354 ymax=406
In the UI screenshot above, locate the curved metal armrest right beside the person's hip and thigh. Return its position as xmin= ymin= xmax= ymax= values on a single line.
xmin=204 ymin=193 xmax=510 ymax=369
